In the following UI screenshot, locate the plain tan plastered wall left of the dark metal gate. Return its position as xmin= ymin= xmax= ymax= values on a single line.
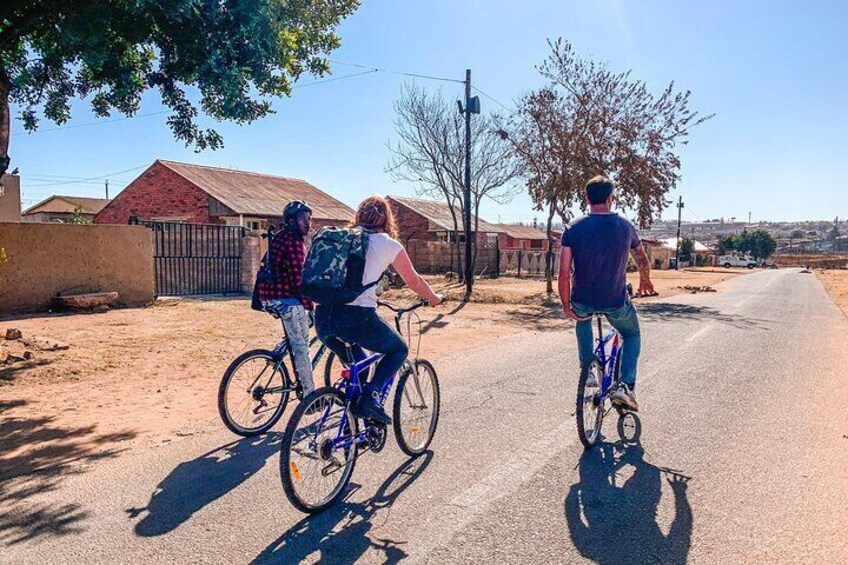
xmin=0 ymin=223 xmax=154 ymax=315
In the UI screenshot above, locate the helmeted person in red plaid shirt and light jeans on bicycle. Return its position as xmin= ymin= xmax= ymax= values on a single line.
xmin=259 ymin=200 xmax=315 ymax=395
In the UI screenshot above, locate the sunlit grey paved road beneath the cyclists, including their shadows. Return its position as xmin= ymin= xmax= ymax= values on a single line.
xmin=0 ymin=270 xmax=848 ymax=564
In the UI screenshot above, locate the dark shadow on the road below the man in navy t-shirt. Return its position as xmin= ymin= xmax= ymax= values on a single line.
xmin=565 ymin=415 xmax=692 ymax=565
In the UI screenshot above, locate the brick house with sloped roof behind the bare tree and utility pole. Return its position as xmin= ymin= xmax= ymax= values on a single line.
xmin=387 ymin=196 xmax=501 ymax=244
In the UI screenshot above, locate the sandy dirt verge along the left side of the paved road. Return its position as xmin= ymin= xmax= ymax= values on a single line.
xmin=0 ymin=269 xmax=748 ymax=481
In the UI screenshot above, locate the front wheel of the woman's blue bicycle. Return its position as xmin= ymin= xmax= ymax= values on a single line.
xmin=392 ymin=359 xmax=441 ymax=457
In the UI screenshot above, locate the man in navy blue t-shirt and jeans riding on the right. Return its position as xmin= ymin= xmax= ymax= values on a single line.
xmin=559 ymin=176 xmax=654 ymax=412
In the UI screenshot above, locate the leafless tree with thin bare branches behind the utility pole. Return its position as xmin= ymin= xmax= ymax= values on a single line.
xmin=387 ymin=84 xmax=518 ymax=290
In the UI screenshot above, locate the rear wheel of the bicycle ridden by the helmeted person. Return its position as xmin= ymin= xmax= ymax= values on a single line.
xmin=218 ymin=349 xmax=291 ymax=437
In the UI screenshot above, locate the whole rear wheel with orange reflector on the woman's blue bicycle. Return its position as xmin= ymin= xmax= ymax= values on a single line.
xmin=280 ymin=388 xmax=358 ymax=514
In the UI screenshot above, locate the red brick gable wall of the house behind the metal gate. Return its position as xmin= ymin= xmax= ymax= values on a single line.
xmin=94 ymin=162 xmax=214 ymax=224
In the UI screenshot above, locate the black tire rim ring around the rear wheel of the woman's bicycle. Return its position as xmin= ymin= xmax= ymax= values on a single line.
xmin=280 ymin=387 xmax=359 ymax=514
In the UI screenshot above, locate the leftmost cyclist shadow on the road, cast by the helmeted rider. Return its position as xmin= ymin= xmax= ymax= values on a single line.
xmin=126 ymin=433 xmax=282 ymax=537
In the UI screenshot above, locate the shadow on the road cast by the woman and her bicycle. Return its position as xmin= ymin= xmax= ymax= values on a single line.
xmin=251 ymin=451 xmax=433 ymax=564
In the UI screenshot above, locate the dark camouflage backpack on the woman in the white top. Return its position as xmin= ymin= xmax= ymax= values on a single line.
xmin=300 ymin=227 xmax=376 ymax=304
